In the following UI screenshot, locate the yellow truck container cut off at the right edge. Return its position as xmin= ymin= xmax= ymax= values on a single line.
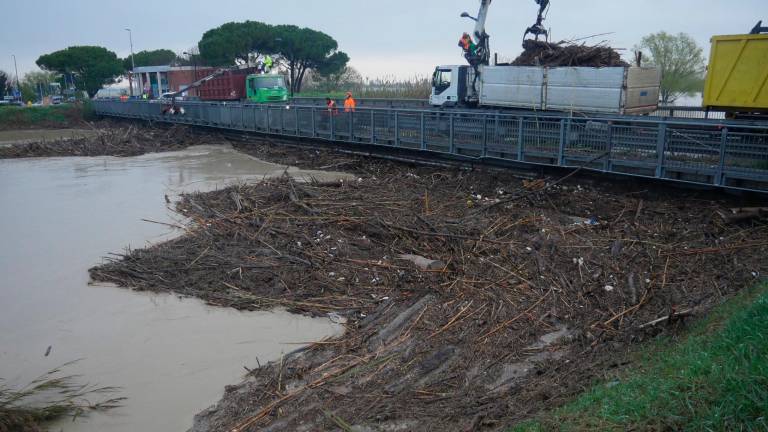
xmin=704 ymin=23 xmax=768 ymax=117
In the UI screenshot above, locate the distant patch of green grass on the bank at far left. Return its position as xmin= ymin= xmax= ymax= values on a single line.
xmin=0 ymin=104 xmax=88 ymax=129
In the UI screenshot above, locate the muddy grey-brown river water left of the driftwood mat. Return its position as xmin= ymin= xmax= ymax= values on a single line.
xmin=0 ymin=146 xmax=340 ymax=432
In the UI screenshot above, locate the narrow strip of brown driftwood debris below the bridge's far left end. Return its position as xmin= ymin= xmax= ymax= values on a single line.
xmin=0 ymin=121 xmax=223 ymax=159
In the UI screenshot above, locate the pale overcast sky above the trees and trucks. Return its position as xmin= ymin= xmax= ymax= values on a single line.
xmin=0 ymin=0 xmax=768 ymax=78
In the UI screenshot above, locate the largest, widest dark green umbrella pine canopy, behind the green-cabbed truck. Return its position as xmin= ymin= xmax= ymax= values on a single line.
xmin=198 ymin=21 xmax=349 ymax=93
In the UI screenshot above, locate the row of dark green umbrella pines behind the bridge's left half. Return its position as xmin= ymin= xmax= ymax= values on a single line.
xmin=30 ymin=21 xmax=349 ymax=96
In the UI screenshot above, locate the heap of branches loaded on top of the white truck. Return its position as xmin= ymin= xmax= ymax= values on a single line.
xmin=512 ymin=39 xmax=628 ymax=67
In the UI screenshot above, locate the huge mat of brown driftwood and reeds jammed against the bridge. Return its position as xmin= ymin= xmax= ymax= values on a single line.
xmin=91 ymin=136 xmax=768 ymax=431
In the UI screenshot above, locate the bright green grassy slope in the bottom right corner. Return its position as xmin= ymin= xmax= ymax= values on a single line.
xmin=512 ymin=285 xmax=768 ymax=432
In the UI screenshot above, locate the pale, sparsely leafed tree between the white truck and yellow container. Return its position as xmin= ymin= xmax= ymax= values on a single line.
xmin=638 ymin=32 xmax=706 ymax=104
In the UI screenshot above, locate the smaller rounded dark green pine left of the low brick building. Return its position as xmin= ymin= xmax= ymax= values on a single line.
xmin=36 ymin=46 xmax=123 ymax=97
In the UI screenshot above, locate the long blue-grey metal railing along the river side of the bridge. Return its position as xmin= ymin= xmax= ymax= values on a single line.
xmin=94 ymin=100 xmax=768 ymax=191
